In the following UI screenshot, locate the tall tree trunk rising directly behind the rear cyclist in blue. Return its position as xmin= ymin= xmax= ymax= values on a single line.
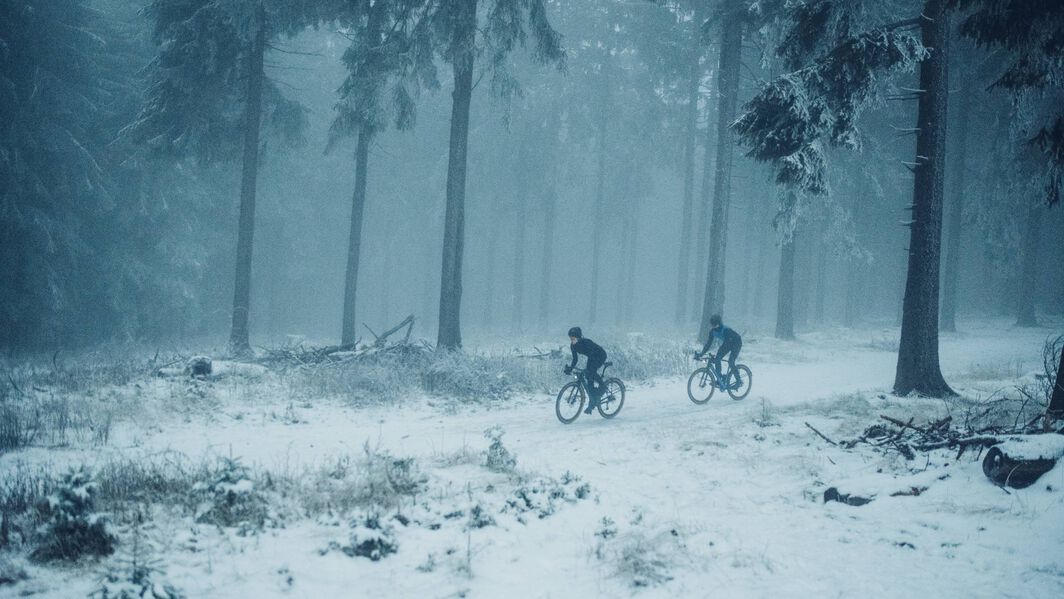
xmin=698 ymin=0 xmax=743 ymax=339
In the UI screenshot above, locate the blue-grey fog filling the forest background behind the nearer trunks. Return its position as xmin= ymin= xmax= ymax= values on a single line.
xmin=0 ymin=0 xmax=1064 ymax=368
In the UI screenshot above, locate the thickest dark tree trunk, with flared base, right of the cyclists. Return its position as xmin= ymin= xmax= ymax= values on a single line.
xmin=894 ymin=0 xmax=955 ymax=397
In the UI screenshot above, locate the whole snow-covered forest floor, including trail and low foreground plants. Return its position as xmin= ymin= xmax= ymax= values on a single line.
xmin=0 ymin=321 xmax=1064 ymax=598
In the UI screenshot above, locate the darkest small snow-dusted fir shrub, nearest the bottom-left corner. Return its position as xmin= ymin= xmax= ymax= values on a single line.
xmin=31 ymin=466 xmax=115 ymax=562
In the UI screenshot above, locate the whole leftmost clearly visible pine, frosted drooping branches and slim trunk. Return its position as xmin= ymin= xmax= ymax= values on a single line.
xmin=130 ymin=0 xmax=314 ymax=353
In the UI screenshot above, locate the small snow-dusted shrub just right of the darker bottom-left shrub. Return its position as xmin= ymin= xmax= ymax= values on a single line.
xmin=193 ymin=457 xmax=269 ymax=530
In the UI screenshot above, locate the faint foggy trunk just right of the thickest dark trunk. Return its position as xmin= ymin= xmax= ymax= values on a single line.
xmin=938 ymin=81 xmax=971 ymax=332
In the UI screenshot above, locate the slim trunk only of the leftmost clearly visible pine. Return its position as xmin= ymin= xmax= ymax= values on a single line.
xmin=229 ymin=2 xmax=266 ymax=354
